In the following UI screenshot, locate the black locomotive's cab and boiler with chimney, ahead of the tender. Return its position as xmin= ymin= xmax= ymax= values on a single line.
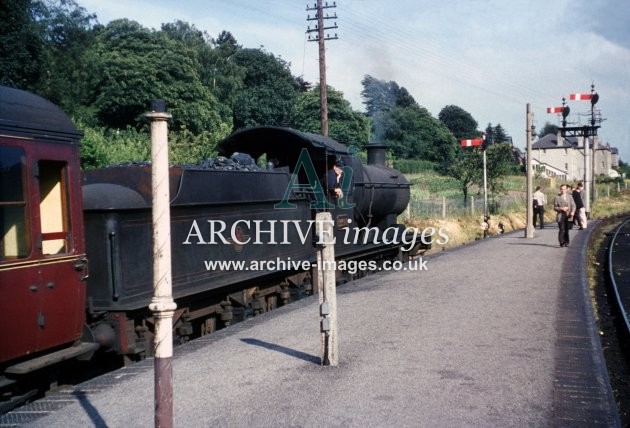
xmin=218 ymin=126 xmax=410 ymax=255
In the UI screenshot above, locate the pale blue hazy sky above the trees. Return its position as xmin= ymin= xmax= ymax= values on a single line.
xmin=77 ymin=0 xmax=630 ymax=162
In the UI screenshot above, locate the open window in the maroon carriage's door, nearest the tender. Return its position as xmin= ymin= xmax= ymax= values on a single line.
xmin=39 ymin=161 xmax=69 ymax=254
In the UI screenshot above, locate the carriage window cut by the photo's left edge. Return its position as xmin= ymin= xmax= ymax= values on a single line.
xmin=0 ymin=147 xmax=31 ymax=261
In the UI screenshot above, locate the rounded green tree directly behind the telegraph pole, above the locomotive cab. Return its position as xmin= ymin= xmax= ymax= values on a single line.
xmin=292 ymin=85 xmax=370 ymax=147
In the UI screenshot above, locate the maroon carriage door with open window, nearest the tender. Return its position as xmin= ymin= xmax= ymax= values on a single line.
xmin=36 ymin=160 xmax=85 ymax=349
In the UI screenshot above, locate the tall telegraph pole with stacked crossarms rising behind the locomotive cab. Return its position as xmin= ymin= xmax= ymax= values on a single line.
xmin=306 ymin=0 xmax=338 ymax=136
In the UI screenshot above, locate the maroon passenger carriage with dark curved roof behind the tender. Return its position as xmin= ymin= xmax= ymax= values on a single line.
xmin=0 ymin=87 xmax=95 ymax=385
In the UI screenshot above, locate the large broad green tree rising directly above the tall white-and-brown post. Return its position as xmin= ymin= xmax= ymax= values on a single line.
xmin=81 ymin=19 xmax=226 ymax=133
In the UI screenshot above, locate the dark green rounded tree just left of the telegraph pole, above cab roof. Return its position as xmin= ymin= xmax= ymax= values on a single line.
xmin=233 ymin=49 xmax=299 ymax=129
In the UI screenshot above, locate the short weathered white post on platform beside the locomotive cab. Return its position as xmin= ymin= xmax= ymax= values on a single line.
xmin=315 ymin=212 xmax=339 ymax=366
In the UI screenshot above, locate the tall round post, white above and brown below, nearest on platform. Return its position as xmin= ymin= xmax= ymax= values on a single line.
xmin=146 ymin=100 xmax=177 ymax=428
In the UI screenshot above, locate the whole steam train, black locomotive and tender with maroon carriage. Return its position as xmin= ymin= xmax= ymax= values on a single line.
xmin=0 ymin=87 xmax=421 ymax=410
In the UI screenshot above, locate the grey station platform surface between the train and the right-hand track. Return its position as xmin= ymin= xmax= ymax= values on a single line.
xmin=9 ymin=227 xmax=619 ymax=428
